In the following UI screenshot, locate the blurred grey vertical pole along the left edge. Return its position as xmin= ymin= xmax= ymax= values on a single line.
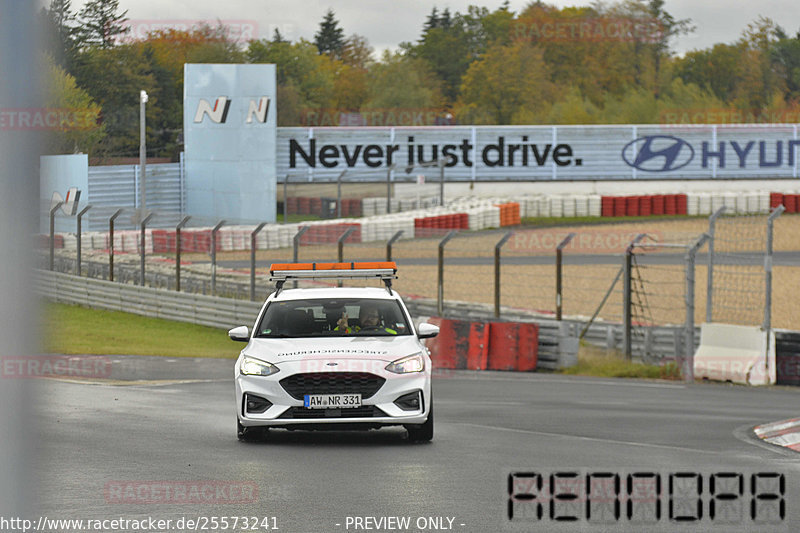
xmin=0 ymin=0 xmax=41 ymax=517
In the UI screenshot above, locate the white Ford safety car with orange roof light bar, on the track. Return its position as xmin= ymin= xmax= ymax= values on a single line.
xmin=228 ymin=262 xmax=439 ymax=441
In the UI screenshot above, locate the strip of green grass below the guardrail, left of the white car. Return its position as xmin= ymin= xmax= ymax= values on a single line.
xmin=43 ymin=303 xmax=238 ymax=358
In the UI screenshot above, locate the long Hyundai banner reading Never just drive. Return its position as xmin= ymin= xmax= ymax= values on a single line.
xmin=277 ymin=124 xmax=800 ymax=181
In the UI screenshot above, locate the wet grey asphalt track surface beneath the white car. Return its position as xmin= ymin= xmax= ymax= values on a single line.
xmin=32 ymin=356 xmax=800 ymax=533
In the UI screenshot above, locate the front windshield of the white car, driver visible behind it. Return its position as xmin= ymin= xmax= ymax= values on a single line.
xmin=255 ymin=298 xmax=411 ymax=338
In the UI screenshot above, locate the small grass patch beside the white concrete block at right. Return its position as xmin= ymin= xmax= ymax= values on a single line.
xmin=560 ymin=344 xmax=681 ymax=380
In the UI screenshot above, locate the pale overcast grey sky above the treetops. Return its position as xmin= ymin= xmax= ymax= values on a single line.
xmin=67 ymin=0 xmax=800 ymax=53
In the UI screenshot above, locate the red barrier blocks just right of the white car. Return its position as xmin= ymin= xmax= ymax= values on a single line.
xmin=427 ymin=317 xmax=539 ymax=372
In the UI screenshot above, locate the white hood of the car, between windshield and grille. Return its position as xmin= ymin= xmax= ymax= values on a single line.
xmin=243 ymin=335 xmax=423 ymax=366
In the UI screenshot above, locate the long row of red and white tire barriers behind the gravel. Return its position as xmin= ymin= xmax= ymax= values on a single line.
xmin=45 ymin=191 xmax=800 ymax=253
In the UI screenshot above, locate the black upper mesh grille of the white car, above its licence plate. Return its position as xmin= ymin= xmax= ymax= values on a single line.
xmin=280 ymin=372 xmax=386 ymax=400
